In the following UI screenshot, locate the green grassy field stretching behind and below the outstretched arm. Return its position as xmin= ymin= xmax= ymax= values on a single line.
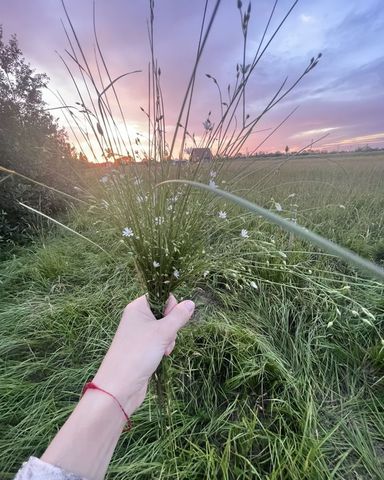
xmin=0 ymin=153 xmax=384 ymax=480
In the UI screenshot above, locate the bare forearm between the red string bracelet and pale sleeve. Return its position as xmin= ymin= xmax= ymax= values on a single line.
xmin=41 ymin=390 xmax=132 ymax=480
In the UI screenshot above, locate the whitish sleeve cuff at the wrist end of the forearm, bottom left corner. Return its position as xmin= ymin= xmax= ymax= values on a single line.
xmin=14 ymin=457 xmax=86 ymax=480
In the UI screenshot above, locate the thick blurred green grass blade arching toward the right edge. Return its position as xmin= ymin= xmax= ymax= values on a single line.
xmin=157 ymin=180 xmax=384 ymax=281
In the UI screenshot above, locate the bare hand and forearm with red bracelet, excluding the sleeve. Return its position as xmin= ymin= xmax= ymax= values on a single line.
xmin=34 ymin=296 xmax=194 ymax=480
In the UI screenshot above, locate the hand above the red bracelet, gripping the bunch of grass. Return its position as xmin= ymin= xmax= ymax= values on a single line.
xmin=93 ymin=295 xmax=195 ymax=415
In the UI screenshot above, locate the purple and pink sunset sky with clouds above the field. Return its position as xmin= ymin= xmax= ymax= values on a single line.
xmin=0 ymin=0 xmax=384 ymax=159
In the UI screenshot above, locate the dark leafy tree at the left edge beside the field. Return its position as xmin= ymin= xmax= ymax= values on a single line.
xmin=0 ymin=26 xmax=81 ymax=243
